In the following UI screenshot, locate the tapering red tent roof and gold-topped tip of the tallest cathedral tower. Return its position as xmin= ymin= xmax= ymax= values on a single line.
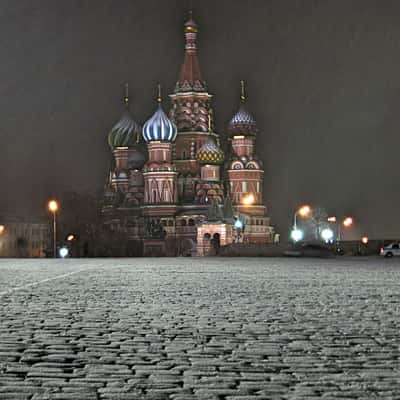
xmin=175 ymin=11 xmax=206 ymax=93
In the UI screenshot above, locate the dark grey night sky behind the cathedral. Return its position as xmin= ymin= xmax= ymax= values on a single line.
xmin=0 ymin=0 xmax=400 ymax=237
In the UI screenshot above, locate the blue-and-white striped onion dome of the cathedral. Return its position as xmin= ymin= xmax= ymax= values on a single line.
xmin=142 ymin=104 xmax=178 ymax=142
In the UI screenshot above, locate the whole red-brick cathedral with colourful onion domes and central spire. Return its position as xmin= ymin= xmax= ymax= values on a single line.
xmin=102 ymin=17 xmax=273 ymax=256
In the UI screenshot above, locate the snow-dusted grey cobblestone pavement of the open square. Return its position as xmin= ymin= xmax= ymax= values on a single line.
xmin=0 ymin=258 xmax=400 ymax=400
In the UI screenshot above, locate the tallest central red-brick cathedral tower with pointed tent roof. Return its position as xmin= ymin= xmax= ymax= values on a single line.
xmin=170 ymin=13 xmax=219 ymax=202
